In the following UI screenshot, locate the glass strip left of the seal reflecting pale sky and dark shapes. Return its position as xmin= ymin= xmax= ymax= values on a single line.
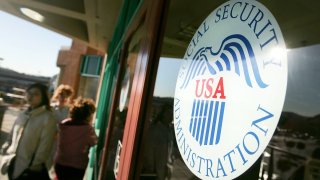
xmin=141 ymin=57 xmax=197 ymax=179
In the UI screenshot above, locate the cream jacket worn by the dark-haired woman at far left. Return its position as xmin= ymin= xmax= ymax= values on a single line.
xmin=4 ymin=106 xmax=57 ymax=178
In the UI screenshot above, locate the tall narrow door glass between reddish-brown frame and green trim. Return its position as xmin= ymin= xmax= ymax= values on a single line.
xmin=98 ymin=24 xmax=144 ymax=179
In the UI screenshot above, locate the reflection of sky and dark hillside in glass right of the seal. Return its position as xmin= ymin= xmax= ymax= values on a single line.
xmin=260 ymin=45 xmax=320 ymax=180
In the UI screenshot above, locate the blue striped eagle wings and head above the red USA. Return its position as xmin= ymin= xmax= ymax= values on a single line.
xmin=180 ymin=34 xmax=268 ymax=89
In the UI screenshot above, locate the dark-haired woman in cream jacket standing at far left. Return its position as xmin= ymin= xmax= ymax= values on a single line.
xmin=1 ymin=83 xmax=57 ymax=180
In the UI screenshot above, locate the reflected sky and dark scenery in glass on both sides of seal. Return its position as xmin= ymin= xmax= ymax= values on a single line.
xmin=141 ymin=45 xmax=320 ymax=180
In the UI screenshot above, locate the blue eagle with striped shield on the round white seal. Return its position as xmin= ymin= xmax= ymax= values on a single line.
xmin=179 ymin=34 xmax=268 ymax=145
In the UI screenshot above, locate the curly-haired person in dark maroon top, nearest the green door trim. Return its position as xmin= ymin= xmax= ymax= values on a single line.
xmin=55 ymin=97 xmax=97 ymax=180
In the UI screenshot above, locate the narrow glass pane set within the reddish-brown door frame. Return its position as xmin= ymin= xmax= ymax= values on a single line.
xmin=106 ymin=25 xmax=142 ymax=179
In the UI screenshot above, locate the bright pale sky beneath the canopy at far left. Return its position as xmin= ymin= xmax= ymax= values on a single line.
xmin=0 ymin=11 xmax=71 ymax=77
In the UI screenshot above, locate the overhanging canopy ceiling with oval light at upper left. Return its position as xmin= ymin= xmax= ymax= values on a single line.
xmin=0 ymin=0 xmax=122 ymax=52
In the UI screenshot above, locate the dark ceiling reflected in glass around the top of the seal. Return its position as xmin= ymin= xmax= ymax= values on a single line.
xmin=162 ymin=0 xmax=320 ymax=58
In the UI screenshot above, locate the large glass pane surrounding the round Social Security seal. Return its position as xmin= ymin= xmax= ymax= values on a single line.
xmin=141 ymin=0 xmax=320 ymax=180
